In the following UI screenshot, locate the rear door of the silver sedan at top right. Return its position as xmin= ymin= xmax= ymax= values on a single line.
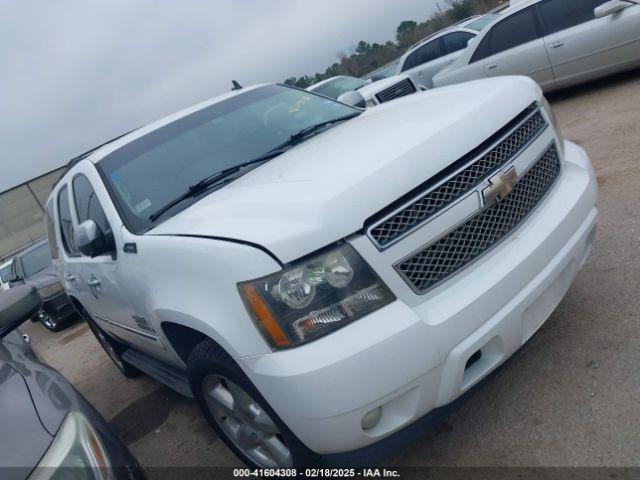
xmin=484 ymin=6 xmax=555 ymax=89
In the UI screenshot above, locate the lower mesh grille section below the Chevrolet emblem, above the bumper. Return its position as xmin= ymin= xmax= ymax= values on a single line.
xmin=394 ymin=144 xmax=560 ymax=294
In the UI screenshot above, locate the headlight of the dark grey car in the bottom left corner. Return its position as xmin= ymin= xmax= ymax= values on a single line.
xmin=29 ymin=412 xmax=111 ymax=480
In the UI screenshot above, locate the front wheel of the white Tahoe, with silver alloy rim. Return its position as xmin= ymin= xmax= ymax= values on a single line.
xmin=187 ymin=340 xmax=320 ymax=468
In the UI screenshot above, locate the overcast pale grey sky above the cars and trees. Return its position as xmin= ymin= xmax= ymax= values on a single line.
xmin=0 ymin=0 xmax=444 ymax=192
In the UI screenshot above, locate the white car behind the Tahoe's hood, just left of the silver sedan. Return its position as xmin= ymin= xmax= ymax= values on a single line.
xmin=396 ymin=15 xmax=492 ymax=89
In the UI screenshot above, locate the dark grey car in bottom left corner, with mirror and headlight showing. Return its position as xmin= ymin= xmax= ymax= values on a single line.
xmin=0 ymin=285 xmax=143 ymax=480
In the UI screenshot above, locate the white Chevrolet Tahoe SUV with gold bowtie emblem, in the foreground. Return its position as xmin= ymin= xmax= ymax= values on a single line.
xmin=47 ymin=77 xmax=597 ymax=467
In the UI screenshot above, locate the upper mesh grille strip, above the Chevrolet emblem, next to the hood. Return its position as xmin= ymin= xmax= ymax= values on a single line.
xmin=368 ymin=110 xmax=547 ymax=250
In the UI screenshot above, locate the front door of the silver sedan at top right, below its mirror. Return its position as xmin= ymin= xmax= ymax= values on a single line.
xmin=540 ymin=0 xmax=640 ymax=87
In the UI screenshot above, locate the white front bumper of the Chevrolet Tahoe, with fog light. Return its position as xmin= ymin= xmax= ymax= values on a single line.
xmin=240 ymin=142 xmax=597 ymax=454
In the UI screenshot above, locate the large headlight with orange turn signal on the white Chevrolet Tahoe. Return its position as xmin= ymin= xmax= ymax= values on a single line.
xmin=238 ymin=244 xmax=395 ymax=348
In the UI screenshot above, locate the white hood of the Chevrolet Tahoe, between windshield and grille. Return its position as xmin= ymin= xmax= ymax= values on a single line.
xmin=148 ymin=77 xmax=541 ymax=262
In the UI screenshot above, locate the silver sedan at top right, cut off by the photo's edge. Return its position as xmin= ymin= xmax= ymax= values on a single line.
xmin=433 ymin=0 xmax=640 ymax=91
